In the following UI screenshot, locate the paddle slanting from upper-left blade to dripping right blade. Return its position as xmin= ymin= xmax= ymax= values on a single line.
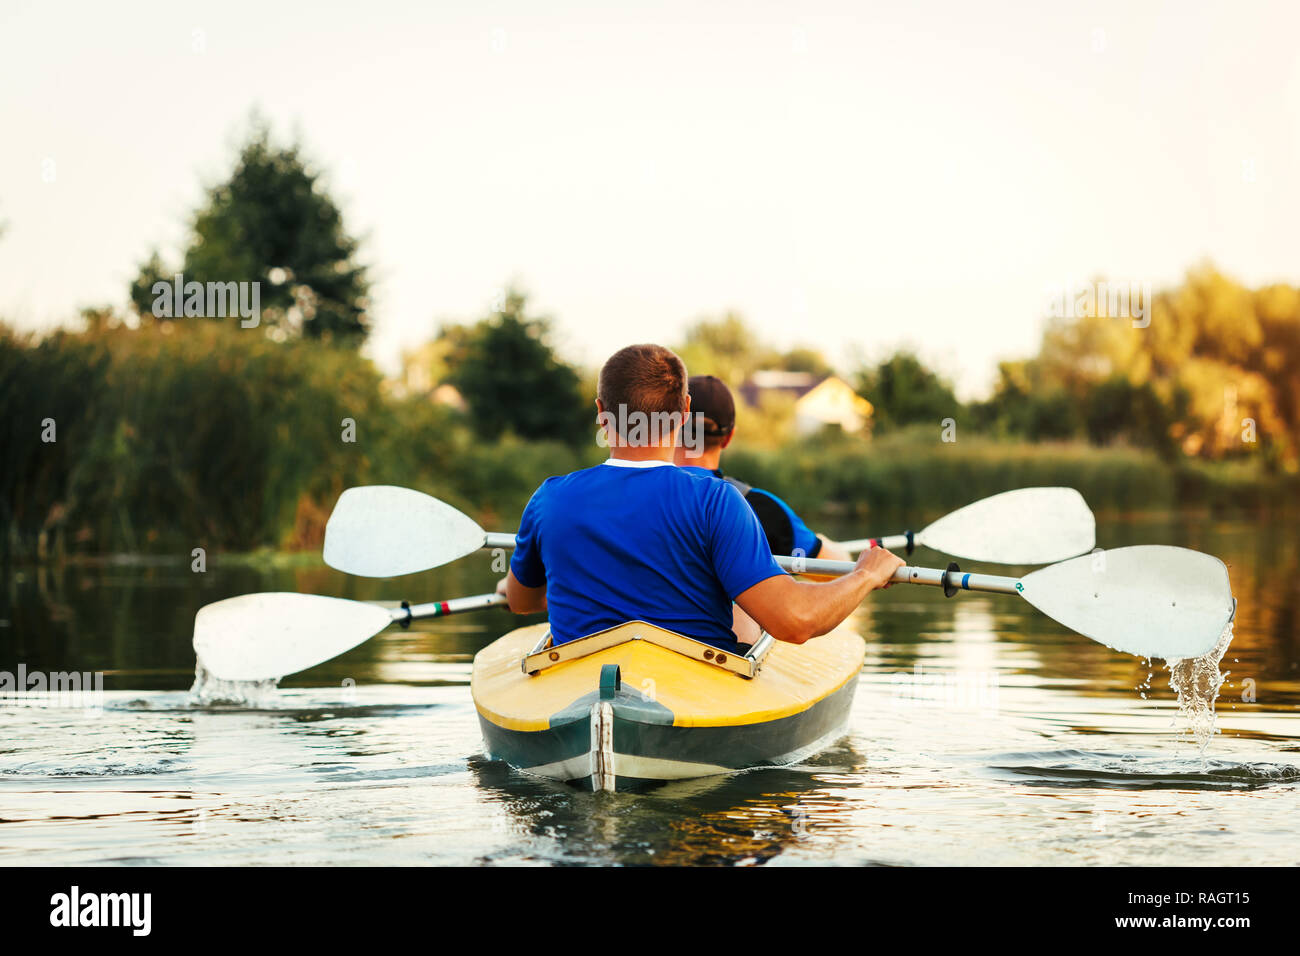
xmin=325 ymin=485 xmax=1234 ymax=659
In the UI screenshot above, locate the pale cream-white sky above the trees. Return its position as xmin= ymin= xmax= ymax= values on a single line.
xmin=0 ymin=0 xmax=1300 ymax=398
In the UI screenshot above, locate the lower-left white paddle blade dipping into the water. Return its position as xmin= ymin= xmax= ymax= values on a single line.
xmin=194 ymin=593 xmax=393 ymax=680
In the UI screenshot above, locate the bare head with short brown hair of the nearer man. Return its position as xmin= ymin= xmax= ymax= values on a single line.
xmin=595 ymin=345 xmax=690 ymax=447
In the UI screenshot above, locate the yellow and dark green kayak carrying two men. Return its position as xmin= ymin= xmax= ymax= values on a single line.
xmin=471 ymin=620 xmax=866 ymax=791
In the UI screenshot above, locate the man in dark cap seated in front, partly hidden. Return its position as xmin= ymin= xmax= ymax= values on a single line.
xmin=676 ymin=375 xmax=853 ymax=561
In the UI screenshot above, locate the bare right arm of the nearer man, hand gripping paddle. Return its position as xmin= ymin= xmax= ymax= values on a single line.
xmin=733 ymin=548 xmax=904 ymax=644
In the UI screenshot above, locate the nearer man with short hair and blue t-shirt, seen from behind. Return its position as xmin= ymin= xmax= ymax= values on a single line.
xmin=491 ymin=345 xmax=902 ymax=650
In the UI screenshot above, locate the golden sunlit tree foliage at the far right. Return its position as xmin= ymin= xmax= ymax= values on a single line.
xmin=972 ymin=265 xmax=1300 ymax=470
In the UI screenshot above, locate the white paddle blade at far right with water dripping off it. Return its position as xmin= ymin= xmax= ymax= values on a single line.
xmin=1021 ymin=545 xmax=1232 ymax=661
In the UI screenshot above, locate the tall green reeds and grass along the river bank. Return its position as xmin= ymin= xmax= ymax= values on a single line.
xmin=0 ymin=324 xmax=1300 ymax=559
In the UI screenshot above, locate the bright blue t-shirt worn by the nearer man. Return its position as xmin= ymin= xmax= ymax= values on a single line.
xmin=510 ymin=462 xmax=785 ymax=652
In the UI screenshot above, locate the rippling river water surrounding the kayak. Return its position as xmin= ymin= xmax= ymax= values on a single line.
xmin=0 ymin=515 xmax=1300 ymax=866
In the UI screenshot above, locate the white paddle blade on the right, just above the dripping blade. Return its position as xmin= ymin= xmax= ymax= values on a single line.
xmin=917 ymin=488 xmax=1097 ymax=564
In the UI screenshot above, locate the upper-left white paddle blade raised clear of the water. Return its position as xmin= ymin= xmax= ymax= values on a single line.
xmin=324 ymin=485 xmax=488 ymax=578
